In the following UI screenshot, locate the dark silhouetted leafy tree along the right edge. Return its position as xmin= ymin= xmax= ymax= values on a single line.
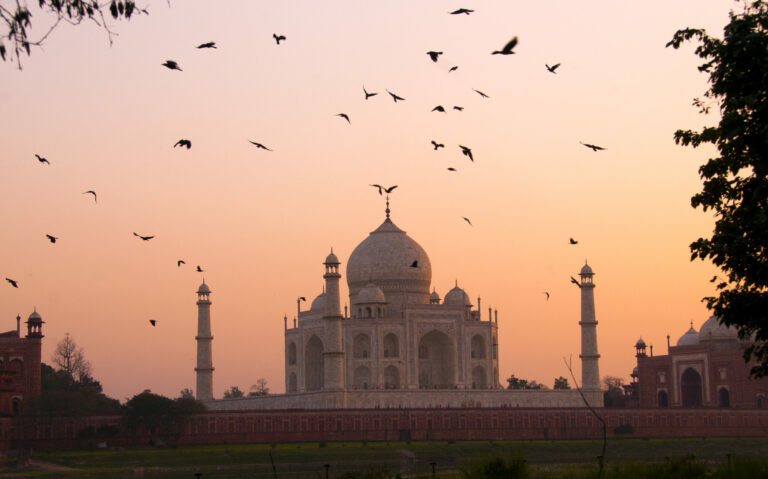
xmin=667 ymin=1 xmax=768 ymax=377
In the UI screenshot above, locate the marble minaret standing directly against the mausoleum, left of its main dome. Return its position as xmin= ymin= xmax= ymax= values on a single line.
xmin=323 ymin=249 xmax=344 ymax=389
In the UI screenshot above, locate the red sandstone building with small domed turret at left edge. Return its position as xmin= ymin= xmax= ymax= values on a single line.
xmin=0 ymin=311 xmax=43 ymax=416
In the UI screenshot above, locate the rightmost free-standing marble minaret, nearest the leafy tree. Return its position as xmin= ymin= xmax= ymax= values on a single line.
xmin=579 ymin=263 xmax=602 ymax=398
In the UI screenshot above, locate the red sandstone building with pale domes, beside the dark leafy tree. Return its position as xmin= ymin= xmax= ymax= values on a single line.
xmin=627 ymin=316 xmax=768 ymax=409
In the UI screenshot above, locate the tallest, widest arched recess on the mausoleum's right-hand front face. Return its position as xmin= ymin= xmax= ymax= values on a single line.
xmin=419 ymin=330 xmax=455 ymax=389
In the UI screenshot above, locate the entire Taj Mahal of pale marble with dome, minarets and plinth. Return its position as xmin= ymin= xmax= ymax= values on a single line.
xmin=200 ymin=201 xmax=603 ymax=410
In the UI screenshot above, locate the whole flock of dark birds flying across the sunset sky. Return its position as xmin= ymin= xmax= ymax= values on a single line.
xmin=5 ymin=8 xmax=605 ymax=316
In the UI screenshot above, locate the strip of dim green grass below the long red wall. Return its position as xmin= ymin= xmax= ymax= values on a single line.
xmin=0 ymin=438 xmax=768 ymax=479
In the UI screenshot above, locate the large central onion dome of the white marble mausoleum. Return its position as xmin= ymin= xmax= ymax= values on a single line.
xmin=347 ymin=218 xmax=432 ymax=300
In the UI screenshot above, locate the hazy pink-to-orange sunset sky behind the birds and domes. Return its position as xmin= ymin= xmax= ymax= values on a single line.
xmin=0 ymin=0 xmax=737 ymax=399
